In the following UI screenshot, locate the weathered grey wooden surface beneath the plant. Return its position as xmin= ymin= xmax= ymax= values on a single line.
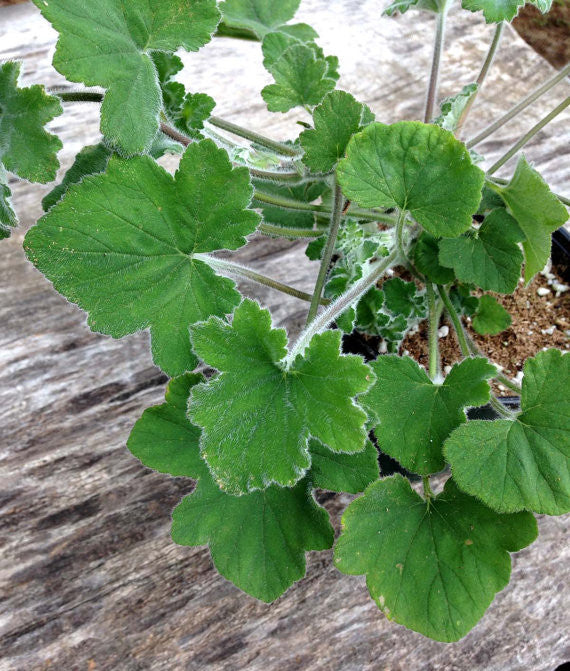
xmin=0 ymin=0 xmax=570 ymax=671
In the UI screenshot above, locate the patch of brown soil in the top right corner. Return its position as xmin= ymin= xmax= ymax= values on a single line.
xmin=513 ymin=0 xmax=570 ymax=68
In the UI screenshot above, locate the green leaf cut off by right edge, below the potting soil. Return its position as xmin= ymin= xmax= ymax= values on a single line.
xmin=444 ymin=349 xmax=570 ymax=515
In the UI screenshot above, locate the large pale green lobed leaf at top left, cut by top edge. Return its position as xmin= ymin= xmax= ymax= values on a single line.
xmin=34 ymin=0 xmax=220 ymax=154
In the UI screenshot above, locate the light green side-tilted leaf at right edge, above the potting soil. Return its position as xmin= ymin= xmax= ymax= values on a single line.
xmin=492 ymin=156 xmax=568 ymax=282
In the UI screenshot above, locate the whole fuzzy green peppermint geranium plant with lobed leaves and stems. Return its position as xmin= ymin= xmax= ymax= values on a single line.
xmin=0 ymin=0 xmax=570 ymax=641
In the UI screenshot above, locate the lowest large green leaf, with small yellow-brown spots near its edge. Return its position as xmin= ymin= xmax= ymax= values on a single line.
xmin=334 ymin=475 xmax=538 ymax=642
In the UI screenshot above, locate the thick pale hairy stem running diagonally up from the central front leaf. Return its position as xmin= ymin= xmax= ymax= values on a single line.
xmin=283 ymin=249 xmax=399 ymax=369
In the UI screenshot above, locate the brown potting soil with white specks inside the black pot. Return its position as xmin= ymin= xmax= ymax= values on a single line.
xmin=400 ymin=268 xmax=570 ymax=396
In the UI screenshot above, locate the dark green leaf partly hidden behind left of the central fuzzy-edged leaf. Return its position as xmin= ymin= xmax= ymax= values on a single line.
xmin=127 ymin=373 xmax=208 ymax=479
